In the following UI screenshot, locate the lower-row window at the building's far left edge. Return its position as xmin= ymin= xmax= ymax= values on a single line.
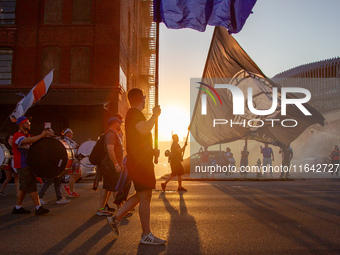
xmin=0 ymin=49 xmax=13 ymax=85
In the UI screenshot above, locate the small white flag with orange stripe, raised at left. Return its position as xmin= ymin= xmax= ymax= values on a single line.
xmin=10 ymin=69 xmax=54 ymax=122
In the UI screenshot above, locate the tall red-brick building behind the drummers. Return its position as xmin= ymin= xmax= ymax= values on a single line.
xmin=0 ymin=0 xmax=155 ymax=143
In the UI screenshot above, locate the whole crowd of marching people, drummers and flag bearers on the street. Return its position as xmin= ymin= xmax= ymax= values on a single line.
xmin=0 ymin=88 xmax=340 ymax=245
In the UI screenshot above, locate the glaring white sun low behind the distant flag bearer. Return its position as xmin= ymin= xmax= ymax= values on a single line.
xmin=158 ymin=104 xmax=190 ymax=142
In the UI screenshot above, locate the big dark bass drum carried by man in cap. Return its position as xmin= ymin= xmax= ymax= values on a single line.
xmin=27 ymin=137 xmax=74 ymax=178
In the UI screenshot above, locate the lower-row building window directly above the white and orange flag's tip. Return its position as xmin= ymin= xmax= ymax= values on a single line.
xmin=41 ymin=47 xmax=61 ymax=84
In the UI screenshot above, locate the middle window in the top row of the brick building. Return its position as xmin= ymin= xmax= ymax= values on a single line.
xmin=44 ymin=0 xmax=63 ymax=24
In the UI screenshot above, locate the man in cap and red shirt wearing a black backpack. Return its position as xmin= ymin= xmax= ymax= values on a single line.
xmin=97 ymin=117 xmax=124 ymax=216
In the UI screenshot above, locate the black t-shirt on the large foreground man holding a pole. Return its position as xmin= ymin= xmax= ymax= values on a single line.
xmin=125 ymin=108 xmax=154 ymax=170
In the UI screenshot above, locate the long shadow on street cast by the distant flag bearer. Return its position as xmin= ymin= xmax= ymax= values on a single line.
xmin=154 ymin=192 xmax=201 ymax=255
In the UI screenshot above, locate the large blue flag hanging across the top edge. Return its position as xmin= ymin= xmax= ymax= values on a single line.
xmin=154 ymin=0 xmax=256 ymax=34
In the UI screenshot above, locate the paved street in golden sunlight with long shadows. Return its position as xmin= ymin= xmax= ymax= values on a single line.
xmin=0 ymin=178 xmax=340 ymax=255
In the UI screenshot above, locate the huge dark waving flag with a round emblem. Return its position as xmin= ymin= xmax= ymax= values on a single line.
xmin=190 ymin=27 xmax=325 ymax=147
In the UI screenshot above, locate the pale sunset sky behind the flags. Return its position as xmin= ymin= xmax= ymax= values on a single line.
xmin=159 ymin=0 xmax=340 ymax=141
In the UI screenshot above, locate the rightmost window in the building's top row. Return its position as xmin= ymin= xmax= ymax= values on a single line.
xmin=72 ymin=0 xmax=92 ymax=24
